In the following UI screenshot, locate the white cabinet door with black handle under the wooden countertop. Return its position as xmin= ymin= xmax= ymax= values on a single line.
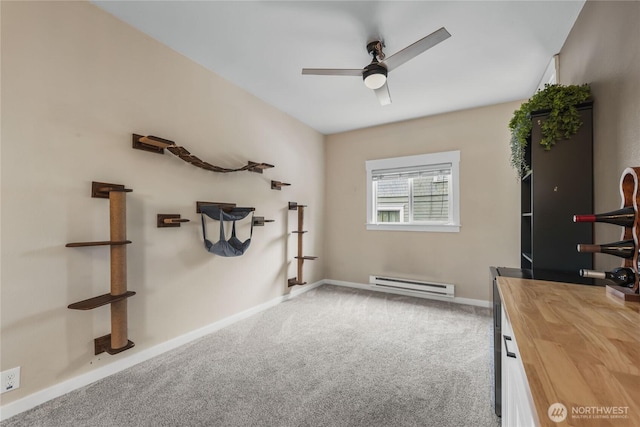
xmin=501 ymin=307 xmax=538 ymax=427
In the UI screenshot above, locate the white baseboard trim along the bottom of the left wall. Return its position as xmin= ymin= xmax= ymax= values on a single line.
xmin=0 ymin=280 xmax=325 ymax=421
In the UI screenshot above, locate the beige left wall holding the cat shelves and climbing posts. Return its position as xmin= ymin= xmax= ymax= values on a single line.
xmin=1 ymin=2 xmax=325 ymax=404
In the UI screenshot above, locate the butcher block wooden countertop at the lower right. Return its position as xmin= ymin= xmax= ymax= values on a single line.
xmin=498 ymin=277 xmax=640 ymax=427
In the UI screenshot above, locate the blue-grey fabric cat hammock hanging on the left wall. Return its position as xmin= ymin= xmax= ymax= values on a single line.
xmin=200 ymin=205 xmax=253 ymax=257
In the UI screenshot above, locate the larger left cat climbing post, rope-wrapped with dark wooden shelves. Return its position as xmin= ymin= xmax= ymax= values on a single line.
xmin=66 ymin=182 xmax=136 ymax=354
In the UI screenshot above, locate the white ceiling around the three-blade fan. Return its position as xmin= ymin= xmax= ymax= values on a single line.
xmin=94 ymin=0 xmax=584 ymax=134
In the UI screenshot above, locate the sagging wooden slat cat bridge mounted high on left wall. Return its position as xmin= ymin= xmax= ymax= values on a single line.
xmin=132 ymin=133 xmax=274 ymax=173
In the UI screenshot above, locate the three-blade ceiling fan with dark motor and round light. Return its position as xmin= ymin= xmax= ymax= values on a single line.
xmin=302 ymin=27 xmax=451 ymax=105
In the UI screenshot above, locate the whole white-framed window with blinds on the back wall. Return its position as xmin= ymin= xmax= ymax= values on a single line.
xmin=366 ymin=151 xmax=460 ymax=232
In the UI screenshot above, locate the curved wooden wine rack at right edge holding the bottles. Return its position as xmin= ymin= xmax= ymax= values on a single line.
xmin=607 ymin=167 xmax=640 ymax=302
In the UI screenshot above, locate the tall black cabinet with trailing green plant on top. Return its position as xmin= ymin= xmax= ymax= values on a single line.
xmin=520 ymin=102 xmax=593 ymax=271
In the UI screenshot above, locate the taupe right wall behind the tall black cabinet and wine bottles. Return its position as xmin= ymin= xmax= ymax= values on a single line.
xmin=560 ymin=1 xmax=640 ymax=269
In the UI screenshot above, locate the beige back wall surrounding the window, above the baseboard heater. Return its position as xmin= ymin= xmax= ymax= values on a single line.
xmin=325 ymin=102 xmax=520 ymax=301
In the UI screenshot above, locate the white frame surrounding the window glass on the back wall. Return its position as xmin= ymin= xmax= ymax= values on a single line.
xmin=365 ymin=150 xmax=460 ymax=233
